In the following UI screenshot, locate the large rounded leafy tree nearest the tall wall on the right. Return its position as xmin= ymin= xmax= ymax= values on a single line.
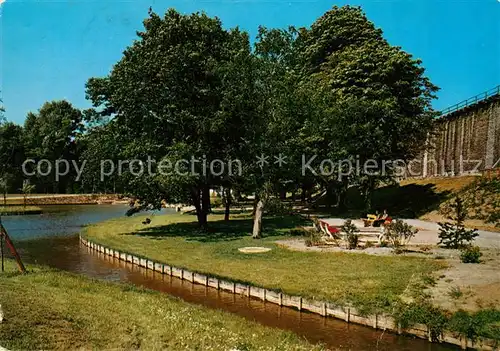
xmin=298 ymin=6 xmax=437 ymax=208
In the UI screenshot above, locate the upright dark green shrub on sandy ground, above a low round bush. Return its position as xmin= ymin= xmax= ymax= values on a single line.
xmin=438 ymin=196 xmax=479 ymax=249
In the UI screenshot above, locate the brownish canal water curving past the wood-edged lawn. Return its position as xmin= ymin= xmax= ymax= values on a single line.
xmin=2 ymin=205 xmax=458 ymax=351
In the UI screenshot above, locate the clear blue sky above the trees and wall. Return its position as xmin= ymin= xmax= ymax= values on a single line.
xmin=0 ymin=0 xmax=500 ymax=123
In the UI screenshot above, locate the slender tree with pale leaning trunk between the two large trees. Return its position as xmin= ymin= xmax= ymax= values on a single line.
xmin=246 ymin=27 xmax=324 ymax=238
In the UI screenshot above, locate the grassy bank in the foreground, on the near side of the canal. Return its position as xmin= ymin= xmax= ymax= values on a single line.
xmin=0 ymin=261 xmax=320 ymax=350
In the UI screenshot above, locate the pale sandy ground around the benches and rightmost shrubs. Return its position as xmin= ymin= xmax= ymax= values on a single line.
xmin=276 ymin=219 xmax=500 ymax=311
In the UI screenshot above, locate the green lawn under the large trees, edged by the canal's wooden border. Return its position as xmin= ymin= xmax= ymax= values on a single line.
xmin=84 ymin=214 xmax=443 ymax=310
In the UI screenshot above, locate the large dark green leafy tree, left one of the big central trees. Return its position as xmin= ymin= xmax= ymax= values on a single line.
xmin=87 ymin=9 xmax=258 ymax=227
